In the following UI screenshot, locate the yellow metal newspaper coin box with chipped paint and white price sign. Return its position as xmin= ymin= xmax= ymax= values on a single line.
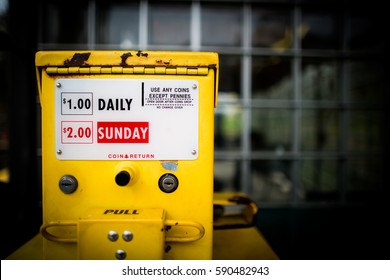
xmin=36 ymin=51 xmax=218 ymax=259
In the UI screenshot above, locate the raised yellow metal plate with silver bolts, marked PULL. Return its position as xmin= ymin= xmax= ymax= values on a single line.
xmin=77 ymin=209 xmax=165 ymax=260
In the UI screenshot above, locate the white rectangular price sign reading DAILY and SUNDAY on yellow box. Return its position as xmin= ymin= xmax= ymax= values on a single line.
xmin=55 ymin=78 xmax=199 ymax=160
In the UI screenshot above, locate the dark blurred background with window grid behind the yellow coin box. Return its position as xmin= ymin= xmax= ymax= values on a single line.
xmin=0 ymin=0 xmax=390 ymax=259
